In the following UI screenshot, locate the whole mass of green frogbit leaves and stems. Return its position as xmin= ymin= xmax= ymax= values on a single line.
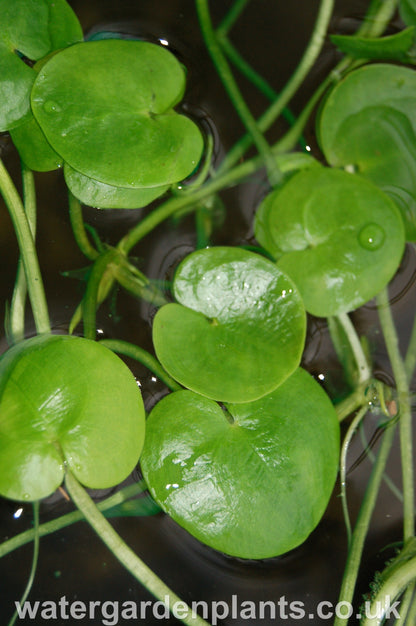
xmin=0 ymin=0 xmax=416 ymax=626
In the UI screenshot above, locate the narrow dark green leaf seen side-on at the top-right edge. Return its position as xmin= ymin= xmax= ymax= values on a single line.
xmin=331 ymin=26 xmax=415 ymax=63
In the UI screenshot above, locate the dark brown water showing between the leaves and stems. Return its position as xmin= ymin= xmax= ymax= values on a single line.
xmin=0 ymin=0 xmax=416 ymax=626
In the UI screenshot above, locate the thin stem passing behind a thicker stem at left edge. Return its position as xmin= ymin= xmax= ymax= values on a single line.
xmin=10 ymin=161 xmax=36 ymax=343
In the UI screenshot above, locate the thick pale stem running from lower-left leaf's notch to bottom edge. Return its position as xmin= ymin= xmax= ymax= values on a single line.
xmin=65 ymin=471 xmax=211 ymax=626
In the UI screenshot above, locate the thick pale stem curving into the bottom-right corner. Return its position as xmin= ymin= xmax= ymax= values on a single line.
xmin=361 ymin=557 xmax=416 ymax=626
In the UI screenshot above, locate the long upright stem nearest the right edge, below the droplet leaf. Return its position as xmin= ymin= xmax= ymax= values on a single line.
xmin=377 ymin=288 xmax=415 ymax=542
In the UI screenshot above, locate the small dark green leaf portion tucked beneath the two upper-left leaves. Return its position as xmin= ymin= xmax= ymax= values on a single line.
xmin=10 ymin=114 xmax=62 ymax=172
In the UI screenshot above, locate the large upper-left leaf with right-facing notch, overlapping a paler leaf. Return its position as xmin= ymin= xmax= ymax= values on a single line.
xmin=32 ymin=39 xmax=203 ymax=188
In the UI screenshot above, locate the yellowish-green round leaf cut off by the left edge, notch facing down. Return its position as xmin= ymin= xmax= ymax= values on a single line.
xmin=0 ymin=335 xmax=144 ymax=500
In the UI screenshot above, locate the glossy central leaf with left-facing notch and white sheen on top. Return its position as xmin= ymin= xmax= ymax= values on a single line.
xmin=153 ymin=247 xmax=305 ymax=402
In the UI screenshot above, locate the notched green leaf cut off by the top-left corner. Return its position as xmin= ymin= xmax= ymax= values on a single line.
xmin=0 ymin=0 xmax=83 ymax=130
